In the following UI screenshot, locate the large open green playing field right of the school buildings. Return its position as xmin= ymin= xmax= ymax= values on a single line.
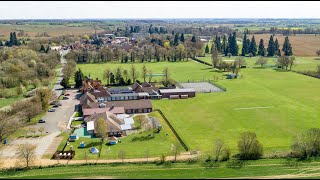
xmin=153 ymin=68 xmax=320 ymax=154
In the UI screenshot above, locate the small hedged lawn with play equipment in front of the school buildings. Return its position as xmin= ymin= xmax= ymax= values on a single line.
xmin=60 ymin=112 xmax=183 ymax=159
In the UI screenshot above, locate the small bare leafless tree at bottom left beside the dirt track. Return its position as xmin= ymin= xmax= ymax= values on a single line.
xmin=16 ymin=144 xmax=36 ymax=168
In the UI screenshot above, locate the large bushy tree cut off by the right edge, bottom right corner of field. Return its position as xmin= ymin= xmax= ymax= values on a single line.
xmin=292 ymin=128 xmax=320 ymax=158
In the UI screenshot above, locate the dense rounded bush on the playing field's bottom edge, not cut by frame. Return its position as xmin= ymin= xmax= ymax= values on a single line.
xmin=238 ymin=132 xmax=263 ymax=160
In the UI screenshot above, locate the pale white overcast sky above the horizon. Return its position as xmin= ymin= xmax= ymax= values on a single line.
xmin=0 ymin=1 xmax=320 ymax=19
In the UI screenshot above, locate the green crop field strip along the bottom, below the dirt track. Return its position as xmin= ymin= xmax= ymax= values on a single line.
xmin=0 ymin=159 xmax=320 ymax=179
